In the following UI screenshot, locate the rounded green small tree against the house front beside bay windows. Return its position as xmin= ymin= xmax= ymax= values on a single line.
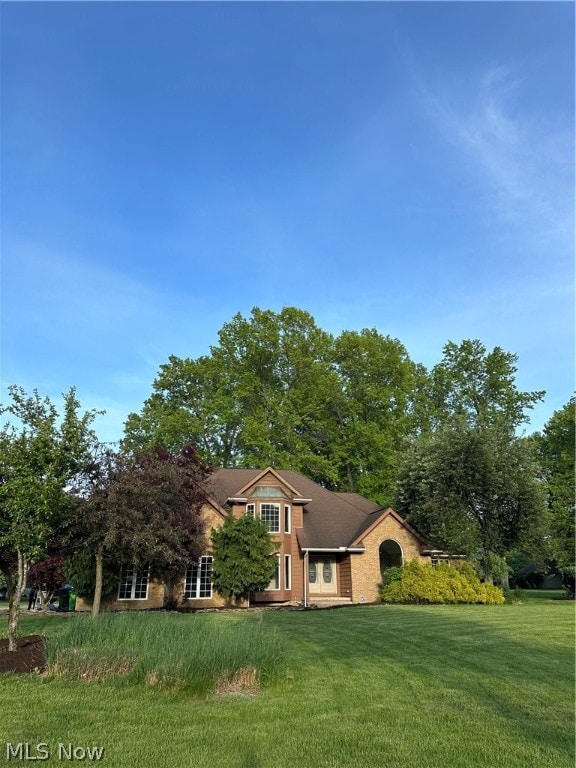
xmin=212 ymin=514 xmax=278 ymax=599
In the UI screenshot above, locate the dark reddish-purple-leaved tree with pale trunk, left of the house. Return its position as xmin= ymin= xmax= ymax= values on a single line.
xmin=70 ymin=446 xmax=210 ymax=616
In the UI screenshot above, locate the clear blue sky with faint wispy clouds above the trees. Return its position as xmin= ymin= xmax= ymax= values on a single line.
xmin=0 ymin=2 xmax=574 ymax=440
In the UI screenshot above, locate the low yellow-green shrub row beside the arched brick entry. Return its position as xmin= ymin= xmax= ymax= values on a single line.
xmin=380 ymin=560 xmax=504 ymax=605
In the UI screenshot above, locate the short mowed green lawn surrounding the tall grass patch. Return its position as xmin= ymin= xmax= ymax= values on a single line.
xmin=0 ymin=599 xmax=574 ymax=768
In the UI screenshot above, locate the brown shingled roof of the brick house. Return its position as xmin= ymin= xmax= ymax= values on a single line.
xmin=210 ymin=469 xmax=385 ymax=549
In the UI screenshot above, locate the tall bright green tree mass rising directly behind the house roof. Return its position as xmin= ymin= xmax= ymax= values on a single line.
xmin=124 ymin=307 xmax=423 ymax=503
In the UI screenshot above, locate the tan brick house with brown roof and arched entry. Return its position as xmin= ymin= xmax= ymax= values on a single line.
xmin=78 ymin=467 xmax=446 ymax=609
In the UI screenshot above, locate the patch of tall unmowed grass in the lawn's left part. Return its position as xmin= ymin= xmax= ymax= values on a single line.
xmin=47 ymin=613 xmax=285 ymax=696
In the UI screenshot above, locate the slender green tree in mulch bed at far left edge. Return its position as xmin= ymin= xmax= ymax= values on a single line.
xmin=0 ymin=386 xmax=97 ymax=650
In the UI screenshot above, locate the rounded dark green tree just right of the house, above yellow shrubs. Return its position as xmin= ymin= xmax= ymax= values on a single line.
xmin=395 ymin=420 xmax=545 ymax=576
